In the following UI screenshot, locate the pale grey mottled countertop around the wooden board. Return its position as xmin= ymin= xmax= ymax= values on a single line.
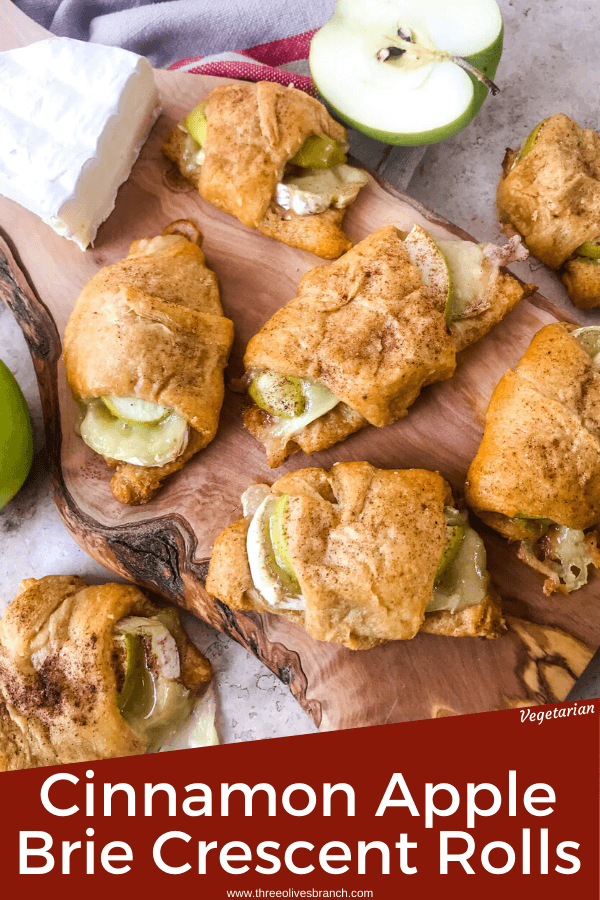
xmin=0 ymin=0 xmax=600 ymax=742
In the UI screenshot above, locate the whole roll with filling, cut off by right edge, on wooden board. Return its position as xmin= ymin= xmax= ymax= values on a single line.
xmin=466 ymin=323 xmax=600 ymax=593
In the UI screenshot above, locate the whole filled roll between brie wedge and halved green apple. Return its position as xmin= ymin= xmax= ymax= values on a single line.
xmin=163 ymin=81 xmax=368 ymax=259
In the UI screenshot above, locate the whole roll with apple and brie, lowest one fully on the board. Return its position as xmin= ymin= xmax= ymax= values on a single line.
xmin=206 ymin=462 xmax=503 ymax=650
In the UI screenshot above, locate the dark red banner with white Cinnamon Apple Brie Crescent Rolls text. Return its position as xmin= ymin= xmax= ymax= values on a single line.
xmin=0 ymin=700 xmax=599 ymax=900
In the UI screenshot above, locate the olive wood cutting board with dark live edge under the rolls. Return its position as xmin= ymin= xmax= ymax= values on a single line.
xmin=0 ymin=0 xmax=600 ymax=729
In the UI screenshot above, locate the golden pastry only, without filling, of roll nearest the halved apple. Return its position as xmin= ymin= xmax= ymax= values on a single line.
xmin=163 ymin=81 xmax=352 ymax=259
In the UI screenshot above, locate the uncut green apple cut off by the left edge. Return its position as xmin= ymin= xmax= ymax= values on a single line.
xmin=0 ymin=360 xmax=33 ymax=509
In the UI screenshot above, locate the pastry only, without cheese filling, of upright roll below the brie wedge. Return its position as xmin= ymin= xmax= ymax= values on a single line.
xmin=64 ymin=229 xmax=233 ymax=504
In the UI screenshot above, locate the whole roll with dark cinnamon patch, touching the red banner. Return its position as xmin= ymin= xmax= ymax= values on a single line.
xmin=0 ymin=575 xmax=214 ymax=771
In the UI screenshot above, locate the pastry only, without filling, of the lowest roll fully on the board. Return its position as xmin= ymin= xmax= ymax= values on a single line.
xmin=206 ymin=462 xmax=502 ymax=650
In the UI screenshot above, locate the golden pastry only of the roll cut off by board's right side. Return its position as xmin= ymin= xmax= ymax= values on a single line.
xmin=466 ymin=323 xmax=600 ymax=537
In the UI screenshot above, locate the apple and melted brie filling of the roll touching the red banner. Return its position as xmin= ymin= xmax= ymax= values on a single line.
xmin=113 ymin=609 xmax=218 ymax=753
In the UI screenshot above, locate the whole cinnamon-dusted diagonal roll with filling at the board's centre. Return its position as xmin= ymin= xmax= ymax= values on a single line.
xmin=244 ymin=225 xmax=535 ymax=466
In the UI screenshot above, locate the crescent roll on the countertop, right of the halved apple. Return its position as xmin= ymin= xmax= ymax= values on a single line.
xmin=497 ymin=113 xmax=600 ymax=309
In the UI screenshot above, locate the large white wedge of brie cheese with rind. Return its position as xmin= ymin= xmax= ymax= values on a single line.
xmin=0 ymin=38 xmax=160 ymax=250
